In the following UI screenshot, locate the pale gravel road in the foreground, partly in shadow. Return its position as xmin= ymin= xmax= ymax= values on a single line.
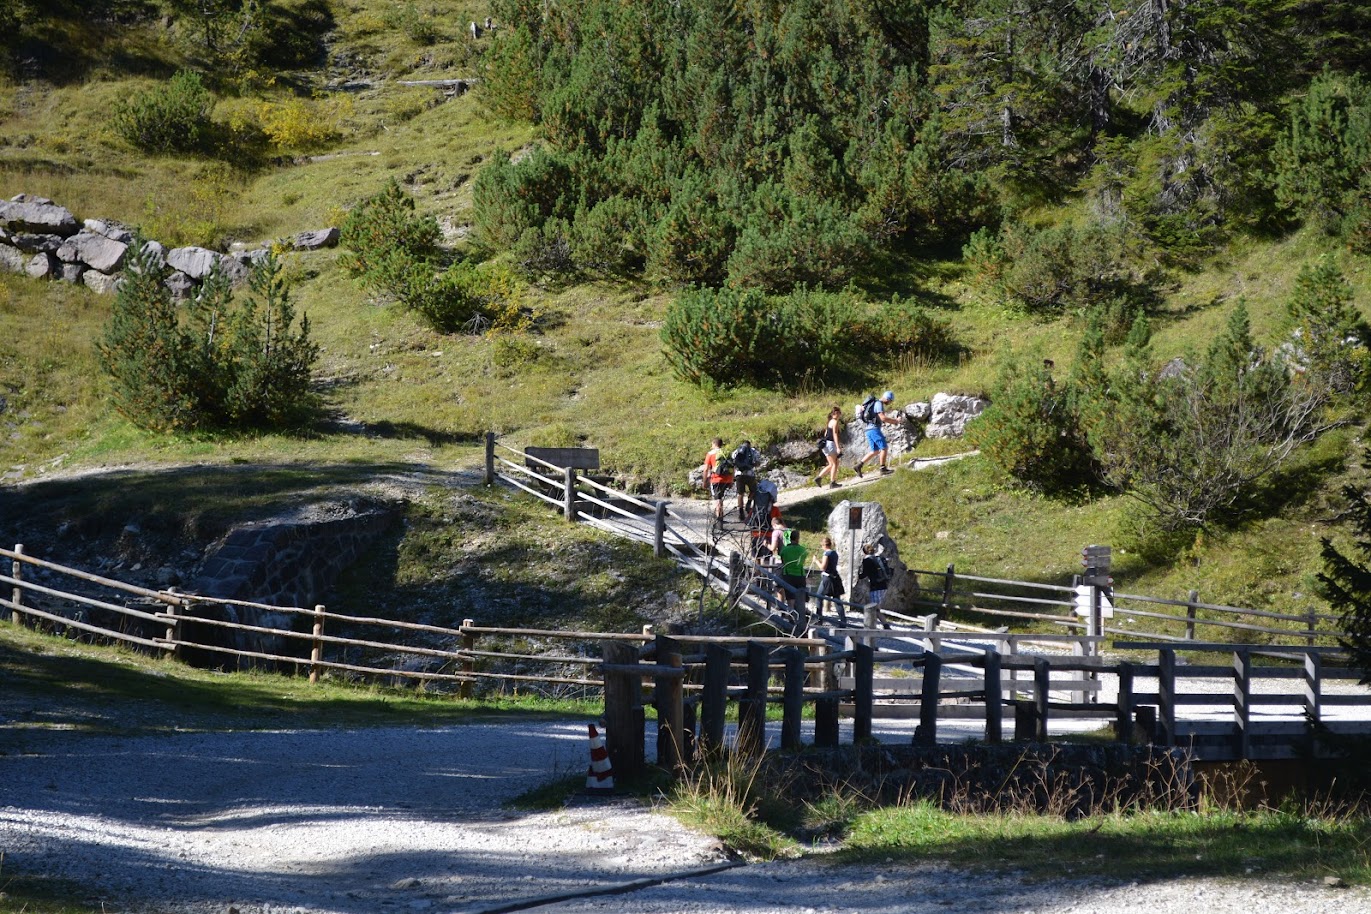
xmin=0 ymin=722 xmax=1371 ymax=914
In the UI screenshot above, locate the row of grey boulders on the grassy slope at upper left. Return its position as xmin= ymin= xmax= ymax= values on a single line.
xmin=0 ymin=193 xmax=339 ymax=299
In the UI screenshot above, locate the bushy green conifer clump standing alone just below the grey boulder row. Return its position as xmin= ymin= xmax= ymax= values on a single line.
xmin=99 ymin=244 xmax=318 ymax=432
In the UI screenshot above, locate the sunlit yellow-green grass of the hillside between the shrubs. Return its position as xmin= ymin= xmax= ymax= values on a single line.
xmin=0 ymin=0 xmax=1371 ymax=619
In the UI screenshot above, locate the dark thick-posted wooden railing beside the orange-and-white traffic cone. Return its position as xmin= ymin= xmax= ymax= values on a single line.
xmin=602 ymin=630 xmax=1371 ymax=774
